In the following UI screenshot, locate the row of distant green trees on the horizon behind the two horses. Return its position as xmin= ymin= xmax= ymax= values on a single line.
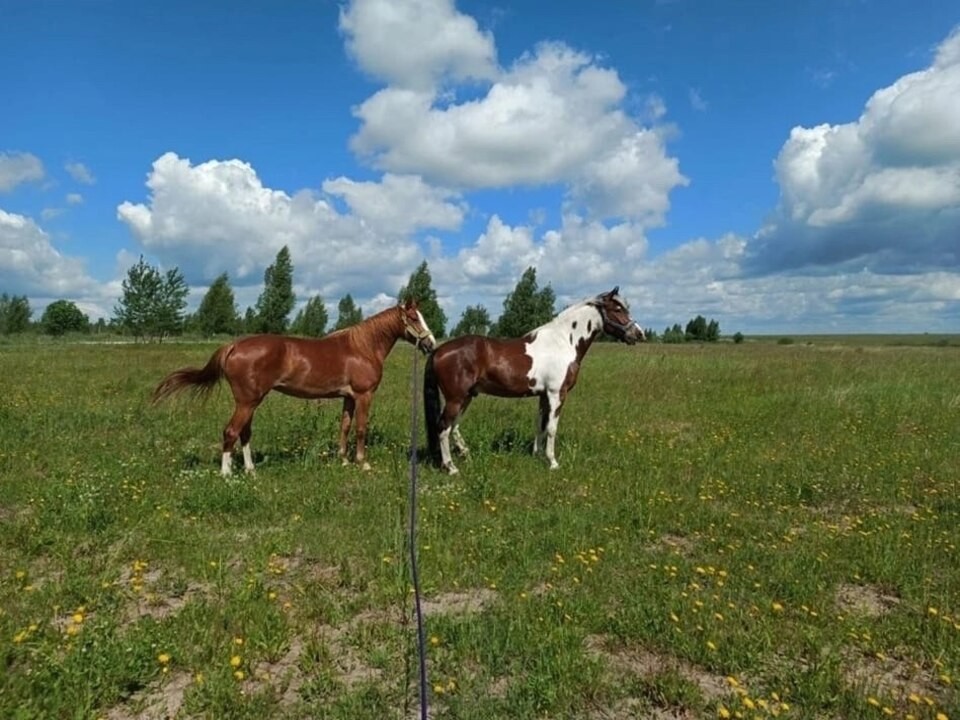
xmin=0 ymin=246 xmax=648 ymax=342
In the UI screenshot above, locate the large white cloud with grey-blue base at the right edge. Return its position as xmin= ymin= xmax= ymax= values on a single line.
xmin=751 ymin=30 xmax=960 ymax=271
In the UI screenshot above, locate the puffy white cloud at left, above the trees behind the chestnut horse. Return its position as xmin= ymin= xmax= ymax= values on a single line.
xmin=117 ymin=153 xmax=428 ymax=297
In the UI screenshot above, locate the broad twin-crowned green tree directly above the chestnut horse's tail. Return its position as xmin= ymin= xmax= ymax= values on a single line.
xmin=114 ymin=255 xmax=189 ymax=342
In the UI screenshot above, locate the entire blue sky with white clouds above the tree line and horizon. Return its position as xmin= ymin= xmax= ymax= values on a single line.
xmin=0 ymin=0 xmax=960 ymax=334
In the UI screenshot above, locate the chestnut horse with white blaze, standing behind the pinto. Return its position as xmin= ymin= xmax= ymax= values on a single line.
xmin=153 ymin=301 xmax=437 ymax=475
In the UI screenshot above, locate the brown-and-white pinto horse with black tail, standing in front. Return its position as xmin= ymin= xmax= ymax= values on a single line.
xmin=423 ymin=286 xmax=646 ymax=475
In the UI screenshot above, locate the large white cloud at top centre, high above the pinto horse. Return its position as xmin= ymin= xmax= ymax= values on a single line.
xmin=341 ymin=0 xmax=687 ymax=226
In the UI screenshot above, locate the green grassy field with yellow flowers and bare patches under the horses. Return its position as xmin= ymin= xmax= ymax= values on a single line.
xmin=0 ymin=341 xmax=960 ymax=720
